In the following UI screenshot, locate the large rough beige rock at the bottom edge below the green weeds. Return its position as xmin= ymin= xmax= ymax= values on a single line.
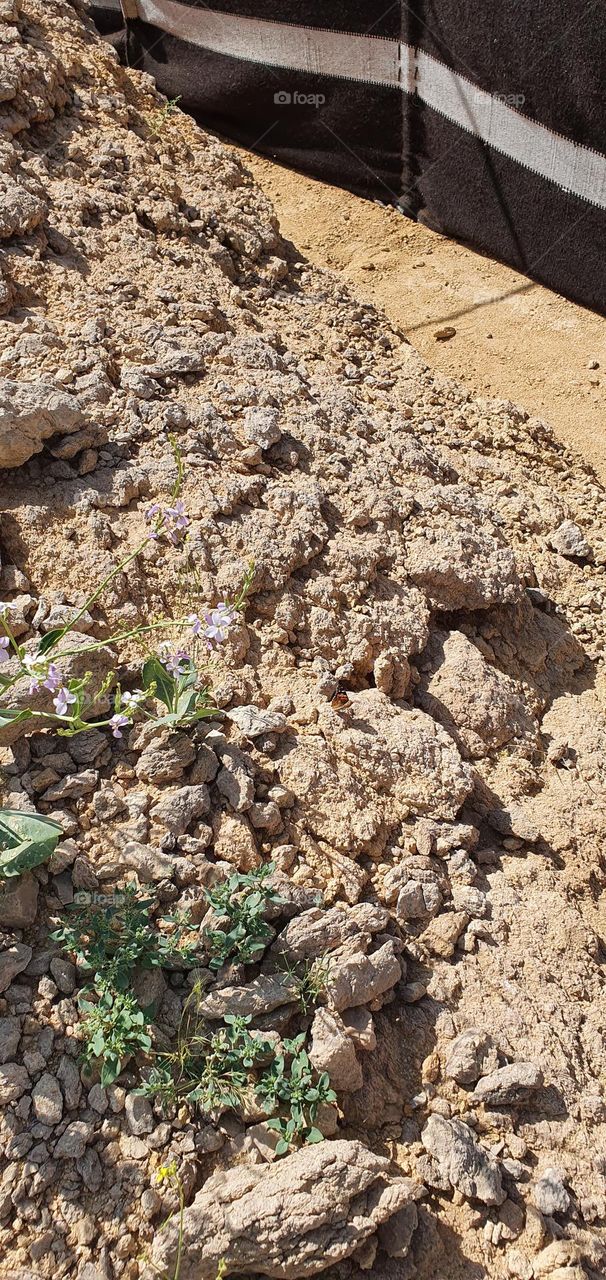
xmin=143 ymin=1140 xmax=411 ymax=1280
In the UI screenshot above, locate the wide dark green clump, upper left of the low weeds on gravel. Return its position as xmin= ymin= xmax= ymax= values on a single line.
xmin=51 ymin=884 xmax=196 ymax=992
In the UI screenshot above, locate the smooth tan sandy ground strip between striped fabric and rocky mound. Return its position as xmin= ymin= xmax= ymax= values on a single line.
xmin=245 ymin=152 xmax=606 ymax=481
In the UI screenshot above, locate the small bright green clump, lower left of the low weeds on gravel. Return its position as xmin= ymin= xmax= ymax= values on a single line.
xmin=79 ymin=987 xmax=151 ymax=1085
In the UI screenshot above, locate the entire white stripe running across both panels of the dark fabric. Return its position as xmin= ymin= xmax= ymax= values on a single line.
xmin=133 ymin=0 xmax=606 ymax=209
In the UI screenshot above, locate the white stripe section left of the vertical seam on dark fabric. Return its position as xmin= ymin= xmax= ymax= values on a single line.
xmin=132 ymin=0 xmax=400 ymax=86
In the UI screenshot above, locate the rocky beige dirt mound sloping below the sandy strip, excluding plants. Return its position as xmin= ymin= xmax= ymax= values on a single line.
xmin=0 ymin=0 xmax=606 ymax=1280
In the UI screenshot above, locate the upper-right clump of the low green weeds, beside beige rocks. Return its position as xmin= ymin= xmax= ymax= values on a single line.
xmin=204 ymin=863 xmax=283 ymax=972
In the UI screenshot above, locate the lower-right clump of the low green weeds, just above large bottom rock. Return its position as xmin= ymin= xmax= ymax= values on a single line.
xmin=255 ymin=1033 xmax=337 ymax=1156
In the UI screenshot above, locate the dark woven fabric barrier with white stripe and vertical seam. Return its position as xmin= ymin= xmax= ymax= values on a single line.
xmin=94 ymin=0 xmax=606 ymax=311
